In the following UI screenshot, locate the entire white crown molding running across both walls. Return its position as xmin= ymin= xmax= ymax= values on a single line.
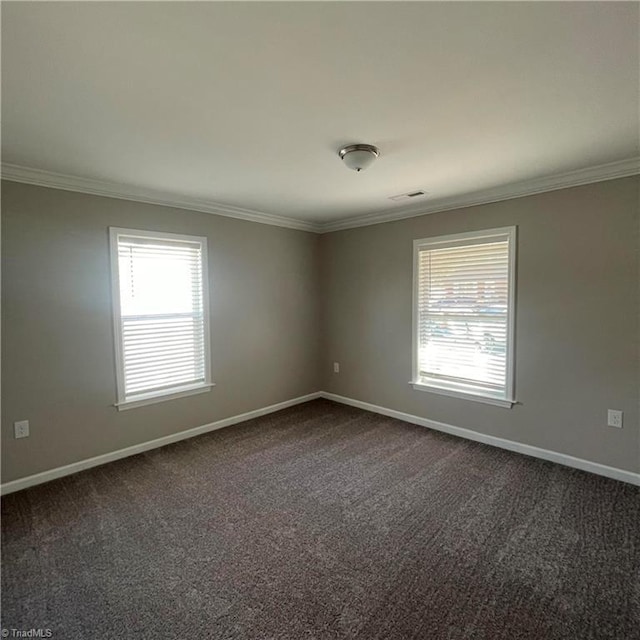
xmin=2 ymin=157 xmax=640 ymax=233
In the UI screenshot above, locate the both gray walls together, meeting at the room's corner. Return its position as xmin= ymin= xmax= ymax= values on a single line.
xmin=2 ymin=178 xmax=640 ymax=482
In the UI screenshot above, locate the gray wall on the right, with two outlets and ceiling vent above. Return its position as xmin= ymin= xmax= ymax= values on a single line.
xmin=321 ymin=178 xmax=640 ymax=471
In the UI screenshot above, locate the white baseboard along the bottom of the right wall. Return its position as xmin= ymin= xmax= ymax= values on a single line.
xmin=320 ymin=391 xmax=640 ymax=486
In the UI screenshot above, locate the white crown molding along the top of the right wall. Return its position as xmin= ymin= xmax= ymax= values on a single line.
xmin=319 ymin=157 xmax=640 ymax=233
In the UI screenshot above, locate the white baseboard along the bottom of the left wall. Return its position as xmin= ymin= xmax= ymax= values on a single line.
xmin=0 ymin=392 xmax=320 ymax=495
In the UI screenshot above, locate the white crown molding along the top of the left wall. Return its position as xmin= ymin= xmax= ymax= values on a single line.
xmin=2 ymin=163 xmax=319 ymax=233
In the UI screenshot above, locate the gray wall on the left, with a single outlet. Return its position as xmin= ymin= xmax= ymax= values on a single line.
xmin=2 ymin=182 xmax=320 ymax=482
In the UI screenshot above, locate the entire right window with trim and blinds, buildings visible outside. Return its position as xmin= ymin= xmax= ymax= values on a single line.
xmin=412 ymin=227 xmax=516 ymax=407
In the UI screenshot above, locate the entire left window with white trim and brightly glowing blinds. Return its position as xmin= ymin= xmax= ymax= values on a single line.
xmin=110 ymin=228 xmax=212 ymax=409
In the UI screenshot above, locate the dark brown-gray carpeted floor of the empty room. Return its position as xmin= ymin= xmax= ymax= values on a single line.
xmin=2 ymin=400 xmax=640 ymax=640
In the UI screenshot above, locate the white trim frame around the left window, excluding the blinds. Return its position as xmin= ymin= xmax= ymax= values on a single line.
xmin=109 ymin=227 xmax=215 ymax=411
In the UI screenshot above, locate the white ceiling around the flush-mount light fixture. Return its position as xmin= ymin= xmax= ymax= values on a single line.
xmin=2 ymin=2 xmax=640 ymax=228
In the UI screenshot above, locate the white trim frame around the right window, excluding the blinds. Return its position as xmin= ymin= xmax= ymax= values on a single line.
xmin=410 ymin=226 xmax=517 ymax=409
